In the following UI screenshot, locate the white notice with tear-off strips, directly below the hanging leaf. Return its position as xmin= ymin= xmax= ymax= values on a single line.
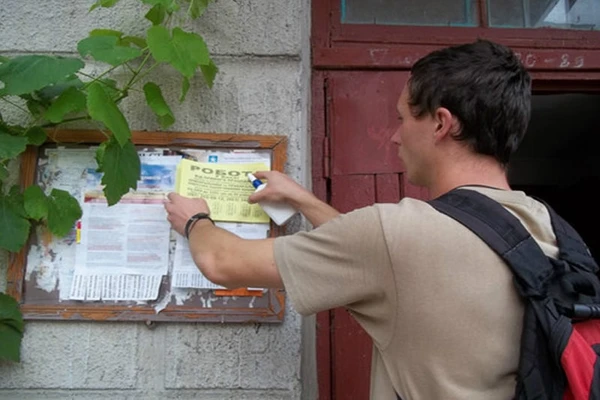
xmin=70 ymin=157 xmax=180 ymax=301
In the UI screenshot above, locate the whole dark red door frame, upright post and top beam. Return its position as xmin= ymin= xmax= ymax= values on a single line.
xmin=311 ymin=0 xmax=600 ymax=400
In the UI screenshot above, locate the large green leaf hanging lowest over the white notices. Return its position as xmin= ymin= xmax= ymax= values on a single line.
xmin=101 ymin=138 xmax=141 ymax=206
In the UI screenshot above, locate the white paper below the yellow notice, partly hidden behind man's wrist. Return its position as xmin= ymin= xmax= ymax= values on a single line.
xmin=171 ymin=222 xmax=269 ymax=289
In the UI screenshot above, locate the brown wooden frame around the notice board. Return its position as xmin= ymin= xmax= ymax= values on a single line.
xmin=7 ymin=130 xmax=287 ymax=323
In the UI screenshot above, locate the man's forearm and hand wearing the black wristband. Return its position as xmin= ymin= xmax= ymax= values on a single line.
xmin=165 ymin=193 xmax=283 ymax=288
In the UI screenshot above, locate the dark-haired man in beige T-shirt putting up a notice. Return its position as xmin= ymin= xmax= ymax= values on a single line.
xmin=165 ymin=41 xmax=557 ymax=400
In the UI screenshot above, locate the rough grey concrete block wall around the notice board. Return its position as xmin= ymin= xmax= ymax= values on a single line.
xmin=0 ymin=0 xmax=315 ymax=400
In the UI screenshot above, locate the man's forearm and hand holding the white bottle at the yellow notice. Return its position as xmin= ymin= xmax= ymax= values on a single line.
xmin=248 ymin=171 xmax=340 ymax=228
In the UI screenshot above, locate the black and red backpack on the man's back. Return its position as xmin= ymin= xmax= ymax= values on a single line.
xmin=429 ymin=189 xmax=600 ymax=400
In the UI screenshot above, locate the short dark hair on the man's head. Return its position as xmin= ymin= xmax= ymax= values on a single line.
xmin=408 ymin=40 xmax=531 ymax=165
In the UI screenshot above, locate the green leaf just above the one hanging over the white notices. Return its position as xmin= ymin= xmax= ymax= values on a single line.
xmin=87 ymin=82 xmax=131 ymax=146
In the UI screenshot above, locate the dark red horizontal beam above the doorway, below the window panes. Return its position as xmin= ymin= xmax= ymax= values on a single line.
xmin=311 ymin=0 xmax=600 ymax=73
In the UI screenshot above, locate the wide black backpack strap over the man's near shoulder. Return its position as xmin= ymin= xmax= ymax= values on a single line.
xmin=428 ymin=189 xmax=553 ymax=297
